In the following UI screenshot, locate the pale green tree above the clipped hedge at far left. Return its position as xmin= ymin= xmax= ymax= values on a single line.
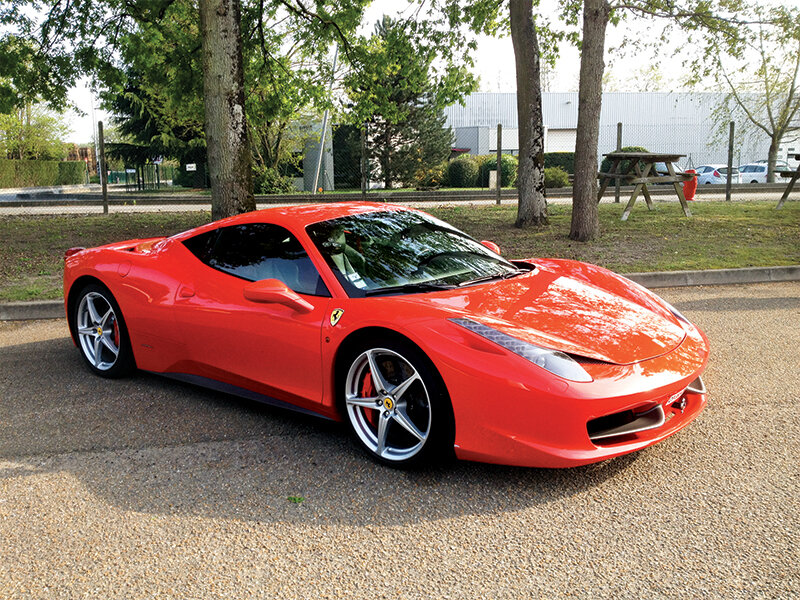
xmin=0 ymin=103 xmax=69 ymax=160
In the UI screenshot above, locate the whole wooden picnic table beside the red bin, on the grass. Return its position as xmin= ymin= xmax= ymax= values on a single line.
xmin=597 ymin=152 xmax=695 ymax=221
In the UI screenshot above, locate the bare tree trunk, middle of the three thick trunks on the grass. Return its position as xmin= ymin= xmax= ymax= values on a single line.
xmin=510 ymin=0 xmax=547 ymax=227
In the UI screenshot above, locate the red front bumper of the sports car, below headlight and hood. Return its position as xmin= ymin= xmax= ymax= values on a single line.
xmin=428 ymin=328 xmax=708 ymax=467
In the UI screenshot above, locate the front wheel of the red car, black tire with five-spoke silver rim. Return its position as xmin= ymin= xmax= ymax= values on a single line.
xmin=337 ymin=337 xmax=455 ymax=468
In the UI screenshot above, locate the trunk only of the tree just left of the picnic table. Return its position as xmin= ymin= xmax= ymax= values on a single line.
xmin=569 ymin=0 xmax=610 ymax=242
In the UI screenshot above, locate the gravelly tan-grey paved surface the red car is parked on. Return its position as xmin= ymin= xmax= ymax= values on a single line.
xmin=0 ymin=282 xmax=800 ymax=599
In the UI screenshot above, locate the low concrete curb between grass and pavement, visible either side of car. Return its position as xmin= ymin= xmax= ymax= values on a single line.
xmin=0 ymin=265 xmax=800 ymax=321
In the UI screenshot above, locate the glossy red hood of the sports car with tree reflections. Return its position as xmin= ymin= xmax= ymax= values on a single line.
xmin=430 ymin=269 xmax=686 ymax=364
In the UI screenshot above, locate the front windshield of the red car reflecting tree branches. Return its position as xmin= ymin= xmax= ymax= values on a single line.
xmin=307 ymin=211 xmax=520 ymax=297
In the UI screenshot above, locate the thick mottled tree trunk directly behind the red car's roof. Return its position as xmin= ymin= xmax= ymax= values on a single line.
xmin=200 ymin=0 xmax=256 ymax=220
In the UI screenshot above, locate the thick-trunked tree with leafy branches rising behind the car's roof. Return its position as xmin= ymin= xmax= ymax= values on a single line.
xmin=0 ymin=0 xmax=368 ymax=216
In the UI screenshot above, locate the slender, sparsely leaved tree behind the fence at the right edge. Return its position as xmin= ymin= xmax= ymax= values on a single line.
xmin=708 ymin=6 xmax=800 ymax=183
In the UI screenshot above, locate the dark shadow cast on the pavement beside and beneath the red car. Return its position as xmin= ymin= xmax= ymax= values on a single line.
xmin=0 ymin=338 xmax=637 ymax=526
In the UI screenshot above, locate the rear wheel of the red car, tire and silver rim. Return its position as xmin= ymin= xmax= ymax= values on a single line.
xmin=69 ymin=283 xmax=136 ymax=379
